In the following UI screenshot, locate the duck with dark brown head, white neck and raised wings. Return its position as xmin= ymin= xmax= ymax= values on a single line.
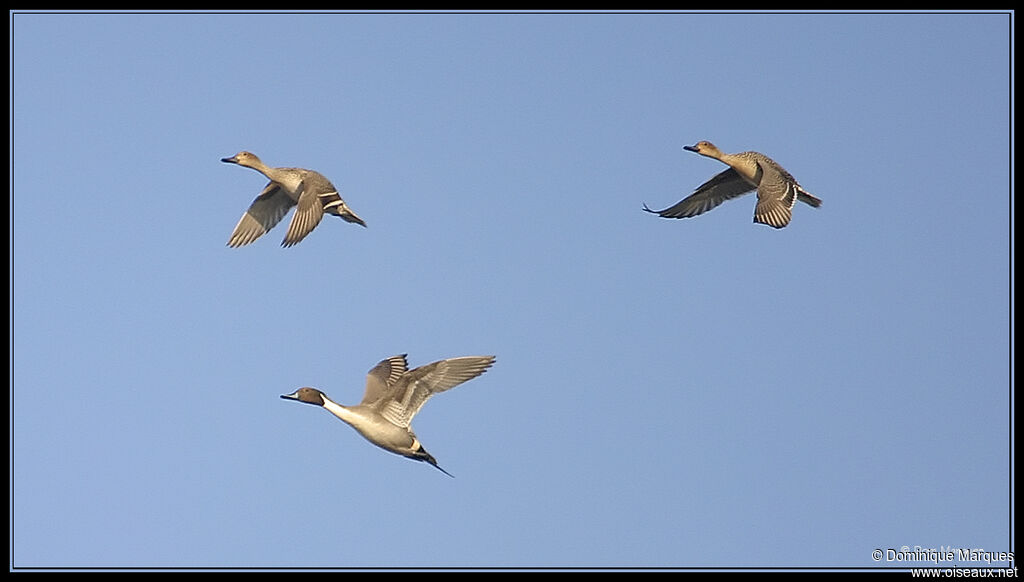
xmin=281 ymin=354 xmax=495 ymax=476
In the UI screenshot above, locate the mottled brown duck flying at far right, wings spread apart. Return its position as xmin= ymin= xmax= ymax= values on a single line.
xmin=643 ymin=141 xmax=821 ymax=228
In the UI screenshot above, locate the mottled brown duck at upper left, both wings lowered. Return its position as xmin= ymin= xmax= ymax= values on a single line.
xmin=220 ymin=152 xmax=367 ymax=247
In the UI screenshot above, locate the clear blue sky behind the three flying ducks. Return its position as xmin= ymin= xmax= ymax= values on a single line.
xmin=10 ymin=13 xmax=1015 ymax=568
